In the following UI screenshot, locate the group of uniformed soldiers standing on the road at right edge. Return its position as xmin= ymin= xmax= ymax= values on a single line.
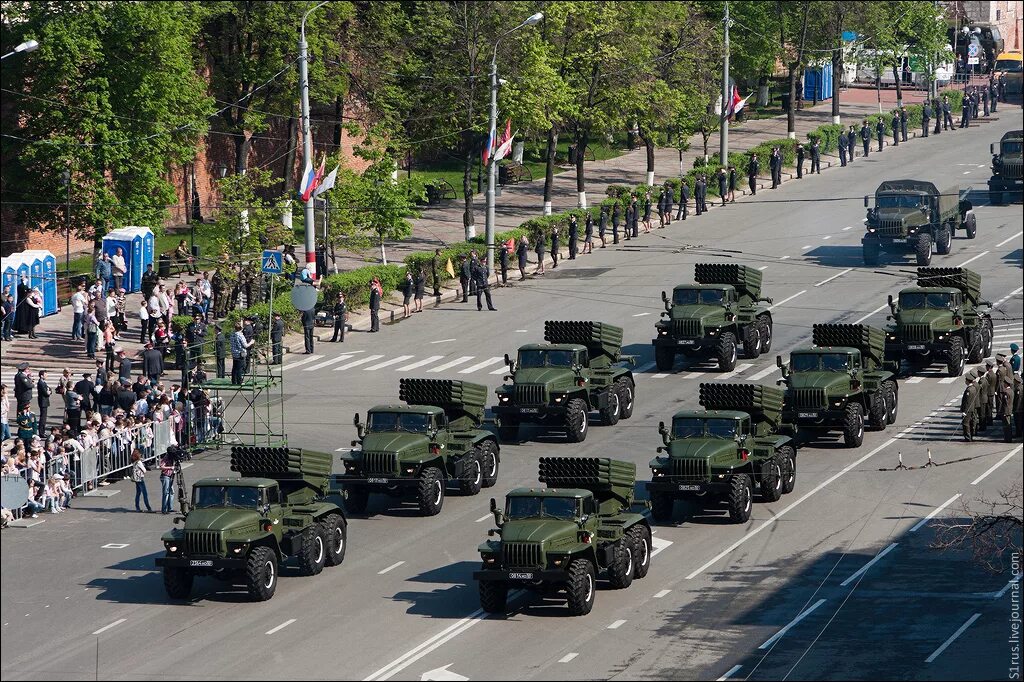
xmin=961 ymin=353 xmax=1024 ymax=442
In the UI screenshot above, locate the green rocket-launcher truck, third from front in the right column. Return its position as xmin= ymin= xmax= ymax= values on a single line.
xmin=775 ymin=325 xmax=899 ymax=447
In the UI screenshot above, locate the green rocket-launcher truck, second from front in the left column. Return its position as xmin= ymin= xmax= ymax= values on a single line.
xmin=338 ymin=378 xmax=501 ymax=516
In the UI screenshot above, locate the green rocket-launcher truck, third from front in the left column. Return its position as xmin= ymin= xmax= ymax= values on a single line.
xmin=494 ymin=319 xmax=636 ymax=442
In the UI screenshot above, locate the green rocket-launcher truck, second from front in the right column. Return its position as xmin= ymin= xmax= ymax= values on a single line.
xmin=647 ymin=383 xmax=797 ymax=523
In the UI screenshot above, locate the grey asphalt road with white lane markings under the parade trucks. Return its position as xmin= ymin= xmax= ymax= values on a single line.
xmin=0 ymin=106 xmax=1024 ymax=680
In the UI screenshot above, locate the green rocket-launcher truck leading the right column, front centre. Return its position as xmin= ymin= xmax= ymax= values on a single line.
xmin=473 ymin=457 xmax=651 ymax=615
